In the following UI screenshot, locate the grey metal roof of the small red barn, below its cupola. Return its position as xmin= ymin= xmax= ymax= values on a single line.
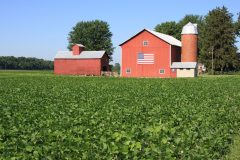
xmin=54 ymin=51 xmax=106 ymax=59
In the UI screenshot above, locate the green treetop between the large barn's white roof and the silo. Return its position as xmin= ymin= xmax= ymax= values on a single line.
xmin=155 ymin=21 xmax=181 ymax=38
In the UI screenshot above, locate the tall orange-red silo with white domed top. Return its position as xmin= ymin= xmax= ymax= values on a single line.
xmin=181 ymin=22 xmax=198 ymax=62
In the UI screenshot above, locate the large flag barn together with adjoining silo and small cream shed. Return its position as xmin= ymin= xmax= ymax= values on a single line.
xmin=120 ymin=23 xmax=198 ymax=78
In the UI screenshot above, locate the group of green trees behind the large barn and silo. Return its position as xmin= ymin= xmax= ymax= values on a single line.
xmin=155 ymin=6 xmax=240 ymax=73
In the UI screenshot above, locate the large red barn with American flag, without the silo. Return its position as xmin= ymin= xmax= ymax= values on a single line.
xmin=120 ymin=29 xmax=181 ymax=78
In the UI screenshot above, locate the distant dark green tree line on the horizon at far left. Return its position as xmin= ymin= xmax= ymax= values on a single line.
xmin=0 ymin=56 xmax=53 ymax=70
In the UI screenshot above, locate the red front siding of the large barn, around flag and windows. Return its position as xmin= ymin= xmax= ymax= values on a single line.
xmin=121 ymin=31 xmax=178 ymax=78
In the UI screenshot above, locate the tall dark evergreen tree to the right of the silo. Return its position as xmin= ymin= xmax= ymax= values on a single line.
xmin=200 ymin=6 xmax=239 ymax=72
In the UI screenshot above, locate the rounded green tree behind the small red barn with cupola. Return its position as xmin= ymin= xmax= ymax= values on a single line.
xmin=68 ymin=20 xmax=114 ymax=59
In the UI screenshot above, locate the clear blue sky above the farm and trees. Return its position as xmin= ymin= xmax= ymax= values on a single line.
xmin=0 ymin=0 xmax=240 ymax=62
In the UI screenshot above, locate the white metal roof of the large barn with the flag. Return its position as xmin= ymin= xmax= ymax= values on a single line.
xmin=120 ymin=29 xmax=182 ymax=47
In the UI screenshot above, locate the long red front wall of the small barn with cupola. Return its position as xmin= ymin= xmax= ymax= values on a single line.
xmin=54 ymin=59 xmax=101 ymax=76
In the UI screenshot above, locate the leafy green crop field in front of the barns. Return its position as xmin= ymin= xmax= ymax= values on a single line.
xmin=0 ymin=71 xmax=240 ymax=160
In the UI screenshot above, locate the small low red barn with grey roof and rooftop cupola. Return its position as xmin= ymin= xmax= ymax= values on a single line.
xmin=54 ymin=44 xmax=110 ymax=76
